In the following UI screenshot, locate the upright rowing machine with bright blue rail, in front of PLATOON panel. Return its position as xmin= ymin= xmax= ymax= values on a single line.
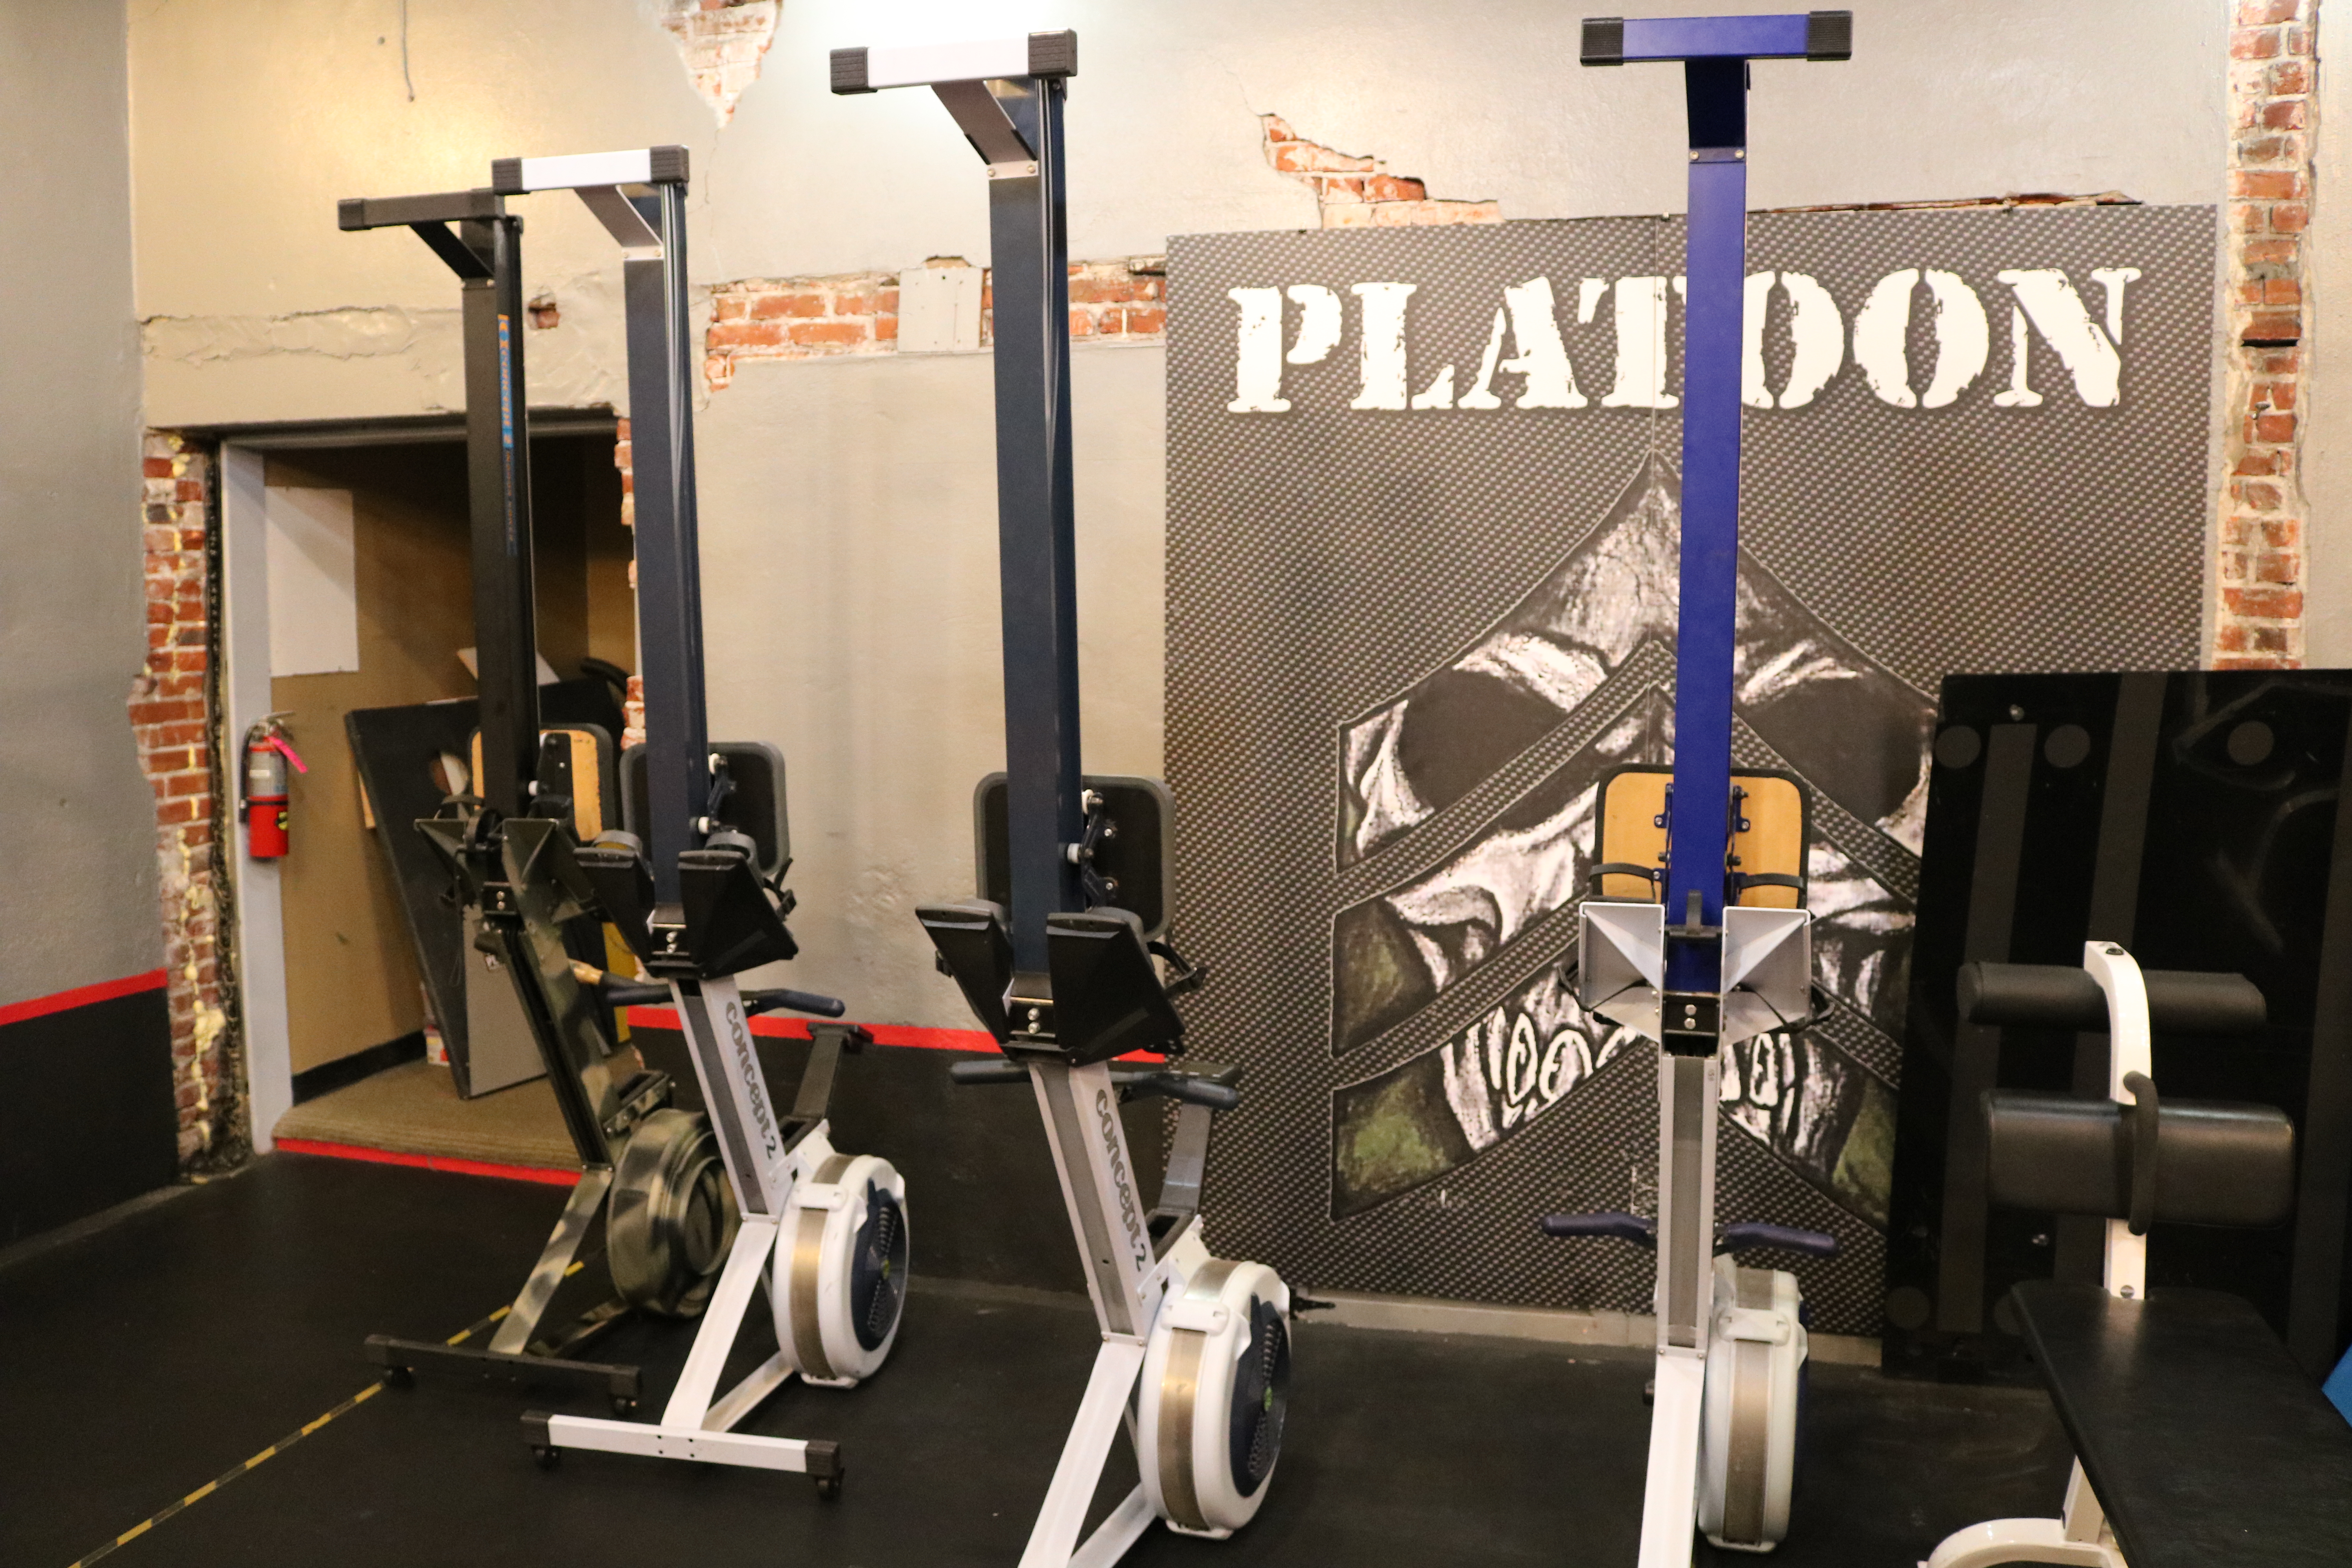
xmin=1543 ymin=12 xmax=1853 ymax=1568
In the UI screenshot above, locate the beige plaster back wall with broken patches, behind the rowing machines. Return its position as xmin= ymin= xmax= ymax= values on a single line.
xmin=132 ymin=0 xmax=2227 ymax=1025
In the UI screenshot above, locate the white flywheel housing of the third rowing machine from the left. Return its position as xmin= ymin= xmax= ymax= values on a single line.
xmin=1136 ymin=1258 xmax=1291 ymax=1537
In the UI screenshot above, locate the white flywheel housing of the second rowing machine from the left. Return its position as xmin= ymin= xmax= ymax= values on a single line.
xmin=771 ymin=1154 xmax=908 ymax=1387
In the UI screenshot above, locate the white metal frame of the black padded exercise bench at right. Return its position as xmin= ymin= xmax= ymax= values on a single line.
xmin=1922 ymin=943 xmax=2154 ymax=1568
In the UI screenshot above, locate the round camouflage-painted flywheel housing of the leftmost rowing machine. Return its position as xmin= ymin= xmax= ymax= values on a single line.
xmin=604 ymin=1107 xmax=736 ymax=1316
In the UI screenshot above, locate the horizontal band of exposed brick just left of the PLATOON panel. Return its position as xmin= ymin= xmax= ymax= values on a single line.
xmin=703 ymin=256 xmax=1167 ymax=390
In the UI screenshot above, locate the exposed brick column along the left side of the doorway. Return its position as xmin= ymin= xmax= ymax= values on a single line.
xmin=129 ymin=435 xmax=247 ymax=1169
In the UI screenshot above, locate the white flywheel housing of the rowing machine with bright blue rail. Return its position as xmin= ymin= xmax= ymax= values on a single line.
xmin=1698 ymin=1258 xmax=1809 ymax=1552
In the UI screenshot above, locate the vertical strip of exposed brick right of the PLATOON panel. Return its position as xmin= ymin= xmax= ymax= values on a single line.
xmin=2211 ymin=0 xmax=2319 ymax=670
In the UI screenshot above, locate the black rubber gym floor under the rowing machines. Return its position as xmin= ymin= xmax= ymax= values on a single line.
xmin=0 ymin=1154 xmax=2067 ymax=1568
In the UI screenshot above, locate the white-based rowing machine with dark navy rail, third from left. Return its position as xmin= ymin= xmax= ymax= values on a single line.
xmin=833 ymin=33 xmax=1291 ymax=1568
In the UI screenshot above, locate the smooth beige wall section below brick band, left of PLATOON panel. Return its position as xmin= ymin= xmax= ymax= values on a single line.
xmin=694 ymin=346 xmax=1167 ymax=1027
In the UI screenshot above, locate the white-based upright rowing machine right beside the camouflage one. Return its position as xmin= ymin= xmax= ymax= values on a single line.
xmin=492 ymin=148 xmax=908 ymax=1497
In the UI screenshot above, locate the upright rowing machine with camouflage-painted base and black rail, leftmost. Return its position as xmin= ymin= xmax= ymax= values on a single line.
xmin=336 ymin=191 xmax=736 ymax=1413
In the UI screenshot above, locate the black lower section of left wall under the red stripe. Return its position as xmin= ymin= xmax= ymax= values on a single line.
xmin=0 ymin=987 xmax=179 ymax=1246
